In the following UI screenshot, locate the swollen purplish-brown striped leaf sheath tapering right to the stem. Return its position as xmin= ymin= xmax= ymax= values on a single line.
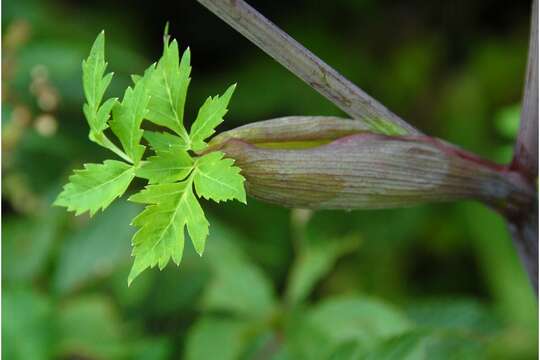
xmin=213 ymin=120 xmax=530 ymax=209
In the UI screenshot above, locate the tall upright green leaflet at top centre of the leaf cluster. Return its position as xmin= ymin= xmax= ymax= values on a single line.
xmin=147 ymin=36 xmax=191 ymax=137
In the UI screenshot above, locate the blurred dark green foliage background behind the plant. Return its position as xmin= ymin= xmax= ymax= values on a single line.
xmin=2 ymin=0 xmax=538 ymax=360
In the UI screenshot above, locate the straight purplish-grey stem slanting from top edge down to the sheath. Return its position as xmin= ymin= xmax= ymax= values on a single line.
xmin=198 ymin=0 xmax=421 ymax=135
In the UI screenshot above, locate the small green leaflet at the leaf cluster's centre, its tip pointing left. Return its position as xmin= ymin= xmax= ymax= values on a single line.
xmin=136 ymin=151 xmax=193 ymax=184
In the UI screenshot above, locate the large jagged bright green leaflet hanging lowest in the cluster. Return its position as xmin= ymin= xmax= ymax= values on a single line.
xmin=128 ymin=177 xmax=209 ymax=283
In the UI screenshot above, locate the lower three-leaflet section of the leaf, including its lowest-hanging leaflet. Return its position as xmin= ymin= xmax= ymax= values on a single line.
xmin=128 ymin=152 xmax=246 ymax=283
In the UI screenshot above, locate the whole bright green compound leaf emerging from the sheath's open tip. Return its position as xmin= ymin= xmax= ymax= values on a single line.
xmin=54 ymin=32 xmax=246 ymax=283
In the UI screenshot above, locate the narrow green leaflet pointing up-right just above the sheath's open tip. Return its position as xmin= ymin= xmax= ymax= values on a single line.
xmin=189 ymin=84 xmax=236 ymax=151
